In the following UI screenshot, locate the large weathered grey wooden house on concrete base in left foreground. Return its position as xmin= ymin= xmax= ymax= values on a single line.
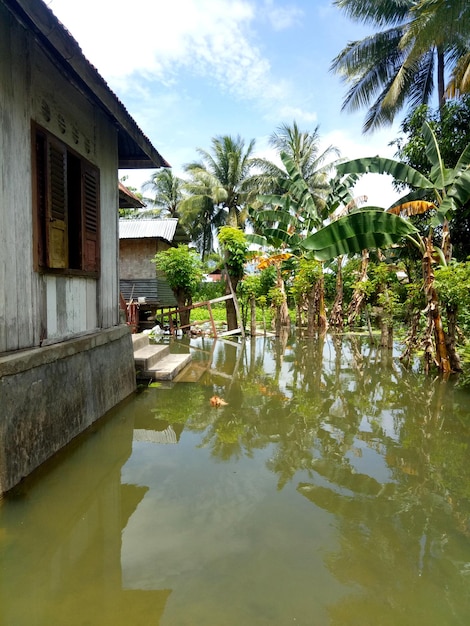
xmin=0 ymin=0 xmax=168 ymax=493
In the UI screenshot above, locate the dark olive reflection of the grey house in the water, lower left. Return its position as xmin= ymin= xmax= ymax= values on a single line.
xmin=0 ymin=405 xmax=171 ymax=626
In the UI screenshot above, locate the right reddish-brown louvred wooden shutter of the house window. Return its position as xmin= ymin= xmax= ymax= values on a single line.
xmin=82 ymin=163 xmax=100 ymax=272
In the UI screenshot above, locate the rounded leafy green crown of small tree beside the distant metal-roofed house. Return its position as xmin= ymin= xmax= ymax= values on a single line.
xmin=154 ymin=245 xmax=202 ymax=294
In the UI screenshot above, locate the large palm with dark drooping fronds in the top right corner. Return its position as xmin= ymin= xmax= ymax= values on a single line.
xmin=331 ymin=0 xmax=469 ymax=132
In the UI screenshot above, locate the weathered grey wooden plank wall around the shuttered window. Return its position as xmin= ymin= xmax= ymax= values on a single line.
xmin=0 ymin=4 xmax=119 ymax=353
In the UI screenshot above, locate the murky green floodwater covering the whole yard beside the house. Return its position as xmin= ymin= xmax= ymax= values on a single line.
xmin=0 ymin=336 xmax=470 ymax=626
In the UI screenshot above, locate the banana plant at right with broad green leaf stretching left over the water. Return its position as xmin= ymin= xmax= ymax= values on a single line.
xmin=302 ymin=123 xmax=470 ymax=374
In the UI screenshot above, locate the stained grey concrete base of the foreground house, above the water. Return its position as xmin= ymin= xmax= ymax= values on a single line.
xmin=0 ymin=326 xmax=136 ymax=494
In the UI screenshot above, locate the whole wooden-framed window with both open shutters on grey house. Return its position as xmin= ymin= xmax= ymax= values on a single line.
xmin=33 ymin=125 xmax=100 ymax=275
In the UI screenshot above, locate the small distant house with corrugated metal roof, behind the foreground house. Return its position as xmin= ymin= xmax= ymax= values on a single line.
xmin=119 ymin=218 xmax=189 ymax=328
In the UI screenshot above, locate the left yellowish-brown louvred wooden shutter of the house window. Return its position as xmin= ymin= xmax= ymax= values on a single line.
xmin=46 ymin=138 xmax=68 ymax=268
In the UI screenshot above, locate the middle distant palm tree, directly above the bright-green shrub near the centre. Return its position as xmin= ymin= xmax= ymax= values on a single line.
xmin=185 ymin=135 xmax=257 ymax=228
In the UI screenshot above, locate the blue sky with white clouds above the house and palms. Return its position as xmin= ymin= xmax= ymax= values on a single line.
xmin=46 ymin=0 xmax=399 ymax=207
